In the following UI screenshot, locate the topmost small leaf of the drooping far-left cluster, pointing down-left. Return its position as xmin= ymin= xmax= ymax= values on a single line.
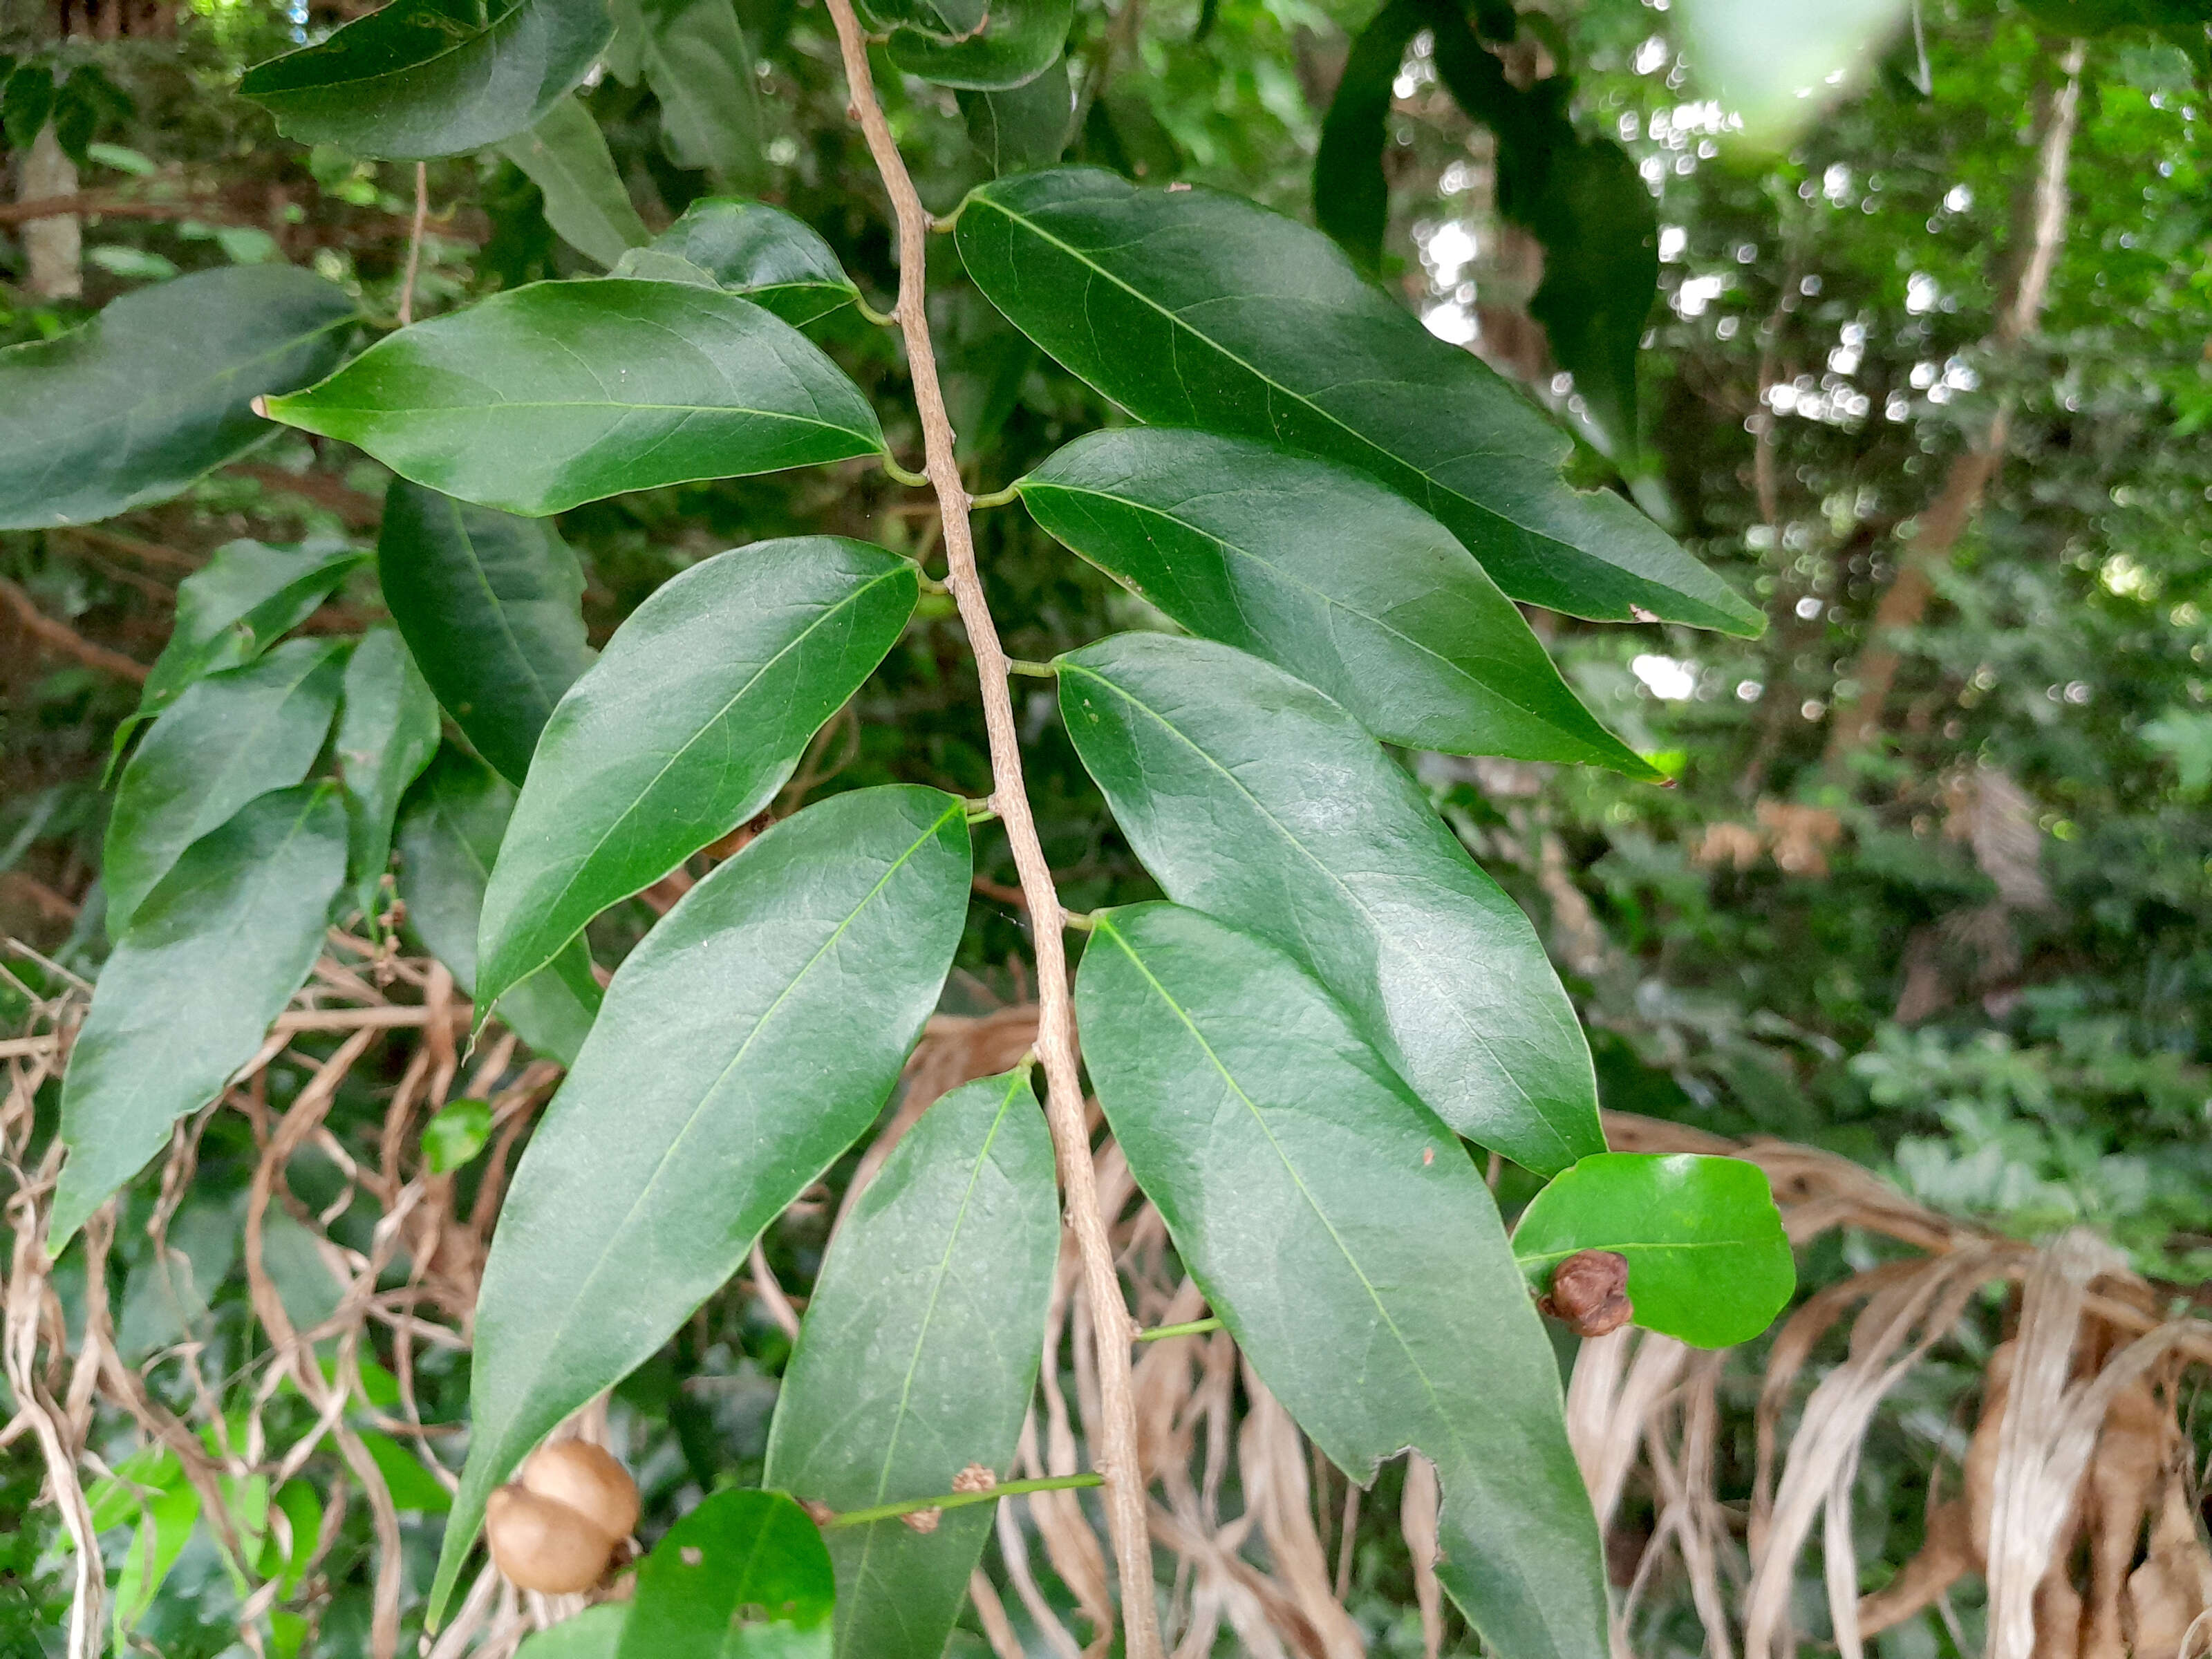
xmin=133 ymin=540 xmax=369 ymax=741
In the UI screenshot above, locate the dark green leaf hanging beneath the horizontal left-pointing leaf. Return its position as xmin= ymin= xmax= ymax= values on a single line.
xmin=376 ymin=478 xmax=593 ymax=783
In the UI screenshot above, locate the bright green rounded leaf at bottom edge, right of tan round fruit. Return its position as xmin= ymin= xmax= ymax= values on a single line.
xmin=615 ymin=1491 xmax=832 ymax=1659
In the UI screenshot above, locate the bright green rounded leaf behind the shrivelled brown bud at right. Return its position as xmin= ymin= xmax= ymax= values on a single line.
xmin=1513 ymin=1152 xmax=1796 ymax=1347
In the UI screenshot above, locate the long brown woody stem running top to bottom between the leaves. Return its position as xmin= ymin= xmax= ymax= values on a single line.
xmin=827 ymin=16 xmax=1161 ymax=1659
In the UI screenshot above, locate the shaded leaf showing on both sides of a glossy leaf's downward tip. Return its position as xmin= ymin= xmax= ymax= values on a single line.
xmin=394 ymin=745 xmax=599 ymax=1064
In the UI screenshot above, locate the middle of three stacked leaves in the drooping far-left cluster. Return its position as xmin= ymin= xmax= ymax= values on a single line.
xmin=100 ymin=639 xmax=345 ymax=938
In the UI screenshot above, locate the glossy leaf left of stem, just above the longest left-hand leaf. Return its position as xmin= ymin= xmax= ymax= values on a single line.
xmin=478 ymin=535 xmax=920 ymax=1000
